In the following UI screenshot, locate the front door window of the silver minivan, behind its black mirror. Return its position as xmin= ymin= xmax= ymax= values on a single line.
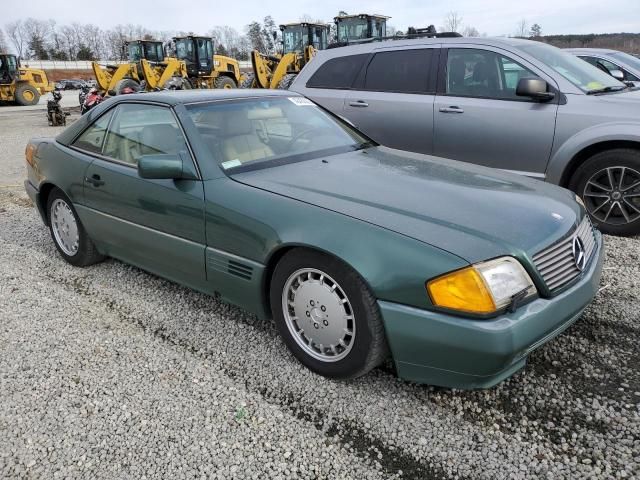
xmin=446 ymin=48 xmax=539 ymax=101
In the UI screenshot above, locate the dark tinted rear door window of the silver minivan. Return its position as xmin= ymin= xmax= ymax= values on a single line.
xmin=364 ymin=49 xmax=433 ymax=93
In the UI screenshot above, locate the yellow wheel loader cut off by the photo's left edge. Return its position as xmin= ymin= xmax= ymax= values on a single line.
xmin=0 ymin=53 xmax=54 ymax=106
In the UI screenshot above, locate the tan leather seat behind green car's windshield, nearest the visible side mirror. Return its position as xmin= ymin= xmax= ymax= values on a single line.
xmin=222 ymin=110 xmax=273 ymax=163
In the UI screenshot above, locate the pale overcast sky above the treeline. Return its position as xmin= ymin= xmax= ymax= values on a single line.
xmin=6 ymin=0 xmax=640 ymax=36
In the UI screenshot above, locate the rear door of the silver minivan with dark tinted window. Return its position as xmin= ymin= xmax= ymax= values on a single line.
xmin=344 ymin=44 xmax=440 ymax=154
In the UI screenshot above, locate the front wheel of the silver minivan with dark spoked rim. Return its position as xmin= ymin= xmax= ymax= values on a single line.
xmin=569 ymin=148 xmax=640 ymax=236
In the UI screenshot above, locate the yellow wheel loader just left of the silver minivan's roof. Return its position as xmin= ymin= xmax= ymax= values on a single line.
xmin=241 ymin=22 xmax=329 ymax=90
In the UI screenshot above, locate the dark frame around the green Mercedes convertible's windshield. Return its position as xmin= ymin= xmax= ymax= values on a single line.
xmin=183 ymin=95 xmax=379 ymax=177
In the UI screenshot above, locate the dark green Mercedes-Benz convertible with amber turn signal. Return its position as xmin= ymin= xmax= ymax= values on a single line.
xmin=25 ymin=90 xmax=603 ymax=388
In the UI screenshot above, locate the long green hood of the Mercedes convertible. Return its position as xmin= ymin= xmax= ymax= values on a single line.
xmin=232 ymin=147 xmax=582 ymax=263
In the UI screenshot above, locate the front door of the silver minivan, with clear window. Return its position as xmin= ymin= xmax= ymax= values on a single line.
xmin=434 ymin=45 xmax=559 ymax=178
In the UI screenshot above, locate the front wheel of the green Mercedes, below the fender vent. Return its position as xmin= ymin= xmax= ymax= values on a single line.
xmin=270 ymin=248 xmax=388 ymax=379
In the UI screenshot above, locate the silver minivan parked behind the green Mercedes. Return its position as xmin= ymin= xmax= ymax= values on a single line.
xmin=291 ymin=38 xmax=640 ymax=235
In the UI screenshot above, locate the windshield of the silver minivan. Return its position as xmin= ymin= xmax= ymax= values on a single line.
xmin=518 ymin=42 xmax=625 ymax=93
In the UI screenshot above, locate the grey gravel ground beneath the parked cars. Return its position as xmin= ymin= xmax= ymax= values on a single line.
xmin=0 ymin=110 xmax=640 ymax=480
